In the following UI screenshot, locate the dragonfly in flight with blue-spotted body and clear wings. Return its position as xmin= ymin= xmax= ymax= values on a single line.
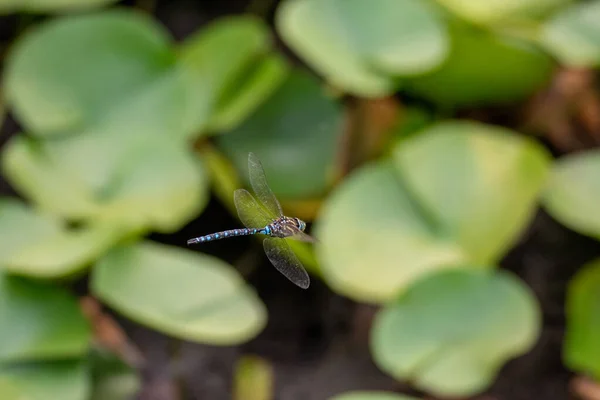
xmin=187 ymin=153 xmax=316 ymax=289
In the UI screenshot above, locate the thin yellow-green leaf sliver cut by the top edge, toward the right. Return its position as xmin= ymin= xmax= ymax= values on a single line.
xmin=437 ymin=0 xmax=573 ymax=24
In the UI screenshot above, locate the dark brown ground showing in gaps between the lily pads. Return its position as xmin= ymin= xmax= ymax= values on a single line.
xmin=0 ymin=0 xmax=600 ymax=400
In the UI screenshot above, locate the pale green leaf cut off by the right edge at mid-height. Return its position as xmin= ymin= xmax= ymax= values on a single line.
xmin=543 ymin=150 xmax=600 ymax=240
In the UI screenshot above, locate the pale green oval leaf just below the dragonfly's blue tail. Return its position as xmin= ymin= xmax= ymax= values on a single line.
xmin=92 ymin=242 xmax=266 ymax=345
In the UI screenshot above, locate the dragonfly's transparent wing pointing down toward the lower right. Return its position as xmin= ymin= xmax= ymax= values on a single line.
xmin=263 ymin=238 xmax=310 ymax=289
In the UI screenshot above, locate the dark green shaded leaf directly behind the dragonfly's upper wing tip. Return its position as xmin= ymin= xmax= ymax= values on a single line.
xmin=217 ymin=70 xmax=343 ymax=200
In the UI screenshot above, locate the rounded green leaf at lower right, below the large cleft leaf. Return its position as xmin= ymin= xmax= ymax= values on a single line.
xmin=371 ymin=267 xmax=541 ymax=397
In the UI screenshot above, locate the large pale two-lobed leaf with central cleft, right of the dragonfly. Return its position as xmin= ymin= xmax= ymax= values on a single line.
xmin=314 ymin=122 xmax=549 ymax=302
